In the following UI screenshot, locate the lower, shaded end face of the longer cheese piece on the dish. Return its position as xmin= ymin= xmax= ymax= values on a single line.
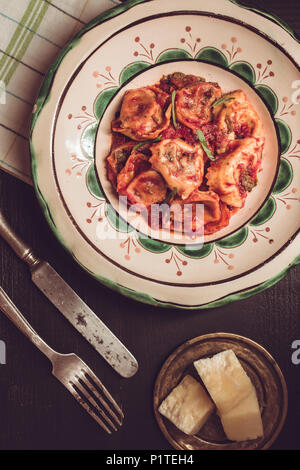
xmin=221 ymin=386 xmax=263 ymax=441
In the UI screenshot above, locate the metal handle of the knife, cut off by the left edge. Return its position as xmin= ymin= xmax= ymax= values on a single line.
xmin=0 ymin=211 xmax=40 ymax=270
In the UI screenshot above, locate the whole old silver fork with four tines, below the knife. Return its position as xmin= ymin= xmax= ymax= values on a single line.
xmin=0 ymin=287 xmax=124 ymax=434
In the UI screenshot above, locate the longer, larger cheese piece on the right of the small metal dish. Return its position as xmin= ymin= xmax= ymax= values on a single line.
xmin=194 ymin=350 xmax=263 ymax=441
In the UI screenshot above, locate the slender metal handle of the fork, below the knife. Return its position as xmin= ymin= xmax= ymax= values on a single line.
xmin=0 ymin=286 xmax=58 ymax=362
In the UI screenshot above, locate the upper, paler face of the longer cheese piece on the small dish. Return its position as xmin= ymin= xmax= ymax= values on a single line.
xmin=194 ymin=349 xmax=252 ymax=414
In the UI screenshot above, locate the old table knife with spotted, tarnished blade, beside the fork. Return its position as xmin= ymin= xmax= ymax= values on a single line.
xmin=0 ymin=211 xmax=138 ymax=378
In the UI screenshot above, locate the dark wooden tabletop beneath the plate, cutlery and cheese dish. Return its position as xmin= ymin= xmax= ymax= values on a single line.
xmin=0 ymin=0 xmax=300 ymax=450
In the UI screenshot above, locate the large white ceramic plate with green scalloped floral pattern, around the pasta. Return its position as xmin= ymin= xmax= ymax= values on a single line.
xmin=31 ymin=0 xmax=300 ymax=308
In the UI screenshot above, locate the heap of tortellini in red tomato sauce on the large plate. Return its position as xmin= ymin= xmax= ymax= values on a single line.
xmin=107 ymin=72 xmax=265 ymax=237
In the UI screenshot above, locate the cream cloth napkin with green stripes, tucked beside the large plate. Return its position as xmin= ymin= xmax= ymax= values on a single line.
xmin=0 ymin=0 xmax=121 ymax=184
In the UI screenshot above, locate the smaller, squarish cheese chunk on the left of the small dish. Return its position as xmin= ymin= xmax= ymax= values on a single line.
xmin=158 ymin=375 xmax=215 ymax=435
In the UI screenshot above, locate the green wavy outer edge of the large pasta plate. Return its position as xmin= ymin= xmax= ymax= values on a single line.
xmin=29 ymin=0 xmax=300 ymax=310
